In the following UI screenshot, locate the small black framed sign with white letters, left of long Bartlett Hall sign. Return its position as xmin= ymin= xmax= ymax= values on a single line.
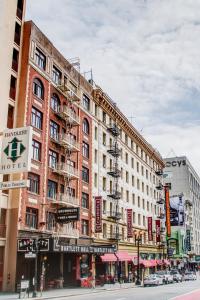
xmin=18 ymin=238 xmax=49 ymax=252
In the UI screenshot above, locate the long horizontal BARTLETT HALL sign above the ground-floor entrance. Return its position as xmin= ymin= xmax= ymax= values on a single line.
xmin=53 ymin=240 xmax=116 ymax=254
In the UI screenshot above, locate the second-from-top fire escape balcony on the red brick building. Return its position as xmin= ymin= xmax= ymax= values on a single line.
xmin=55 ymin=105 xmax=80 ymax=126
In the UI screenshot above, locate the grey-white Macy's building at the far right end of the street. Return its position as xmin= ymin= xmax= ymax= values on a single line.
xmin=164 ymin=156 xmax=200 ymax=257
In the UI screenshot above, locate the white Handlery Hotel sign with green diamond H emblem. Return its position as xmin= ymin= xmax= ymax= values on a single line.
xmin=0 ymin=126 xmax=32 ymax=174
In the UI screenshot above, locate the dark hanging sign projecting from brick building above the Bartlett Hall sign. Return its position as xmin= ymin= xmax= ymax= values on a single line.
xmin=56 ymin=207 xmax=80 ymax=223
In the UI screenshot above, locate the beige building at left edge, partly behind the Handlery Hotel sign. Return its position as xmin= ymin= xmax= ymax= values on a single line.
xmin=0 ymin=0 xmax=25 ymax=290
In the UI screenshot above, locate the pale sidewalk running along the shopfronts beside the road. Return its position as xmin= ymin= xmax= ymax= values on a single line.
xmin=0 ymin=283 xmax=136 ymax=300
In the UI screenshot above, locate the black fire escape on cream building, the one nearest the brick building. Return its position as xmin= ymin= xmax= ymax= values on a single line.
xmin=107 ymin=115 xmax=122 ymax=241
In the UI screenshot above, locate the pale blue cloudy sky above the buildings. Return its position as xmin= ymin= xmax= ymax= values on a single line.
xmin=26 ymin=0 xmax=200 ymax=175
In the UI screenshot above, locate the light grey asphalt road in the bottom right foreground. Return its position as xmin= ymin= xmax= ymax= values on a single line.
xmin=50 ymin=280 xmax=200 ymax=300
